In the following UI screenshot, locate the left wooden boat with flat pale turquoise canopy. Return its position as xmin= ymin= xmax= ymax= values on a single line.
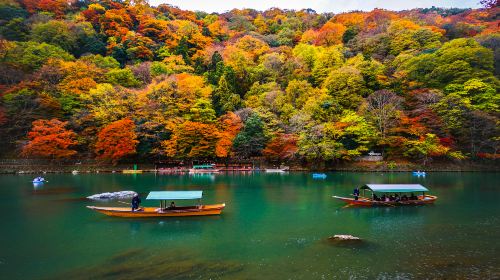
xmin=87 ymin=191 xmax=226 ymax=218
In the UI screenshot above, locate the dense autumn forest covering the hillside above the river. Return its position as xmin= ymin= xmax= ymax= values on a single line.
xmin=0 ymin=0 xmax=500 ymax=163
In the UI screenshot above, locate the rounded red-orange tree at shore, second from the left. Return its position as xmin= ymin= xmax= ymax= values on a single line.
xmin=95 ymin=119 xmax=139 ymax=164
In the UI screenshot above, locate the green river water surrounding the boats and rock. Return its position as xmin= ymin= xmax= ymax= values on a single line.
xmin=0 ymin=172 xmax=500 ymax=279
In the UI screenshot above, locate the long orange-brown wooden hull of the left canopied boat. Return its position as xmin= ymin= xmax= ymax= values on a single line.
xmin=87 ymin=204 xmax=226 ymax=218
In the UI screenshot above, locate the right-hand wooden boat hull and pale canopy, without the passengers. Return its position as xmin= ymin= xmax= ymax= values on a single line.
xmin=333 ymin=184 xmax=438 ymax=207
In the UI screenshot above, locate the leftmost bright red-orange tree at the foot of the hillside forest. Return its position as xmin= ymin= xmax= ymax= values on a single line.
xmin=22 ymin=119 xmax=77 ymax=159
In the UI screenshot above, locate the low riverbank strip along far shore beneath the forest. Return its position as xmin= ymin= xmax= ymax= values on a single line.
xmin=0 ymin=161 xmax=500 ymax=174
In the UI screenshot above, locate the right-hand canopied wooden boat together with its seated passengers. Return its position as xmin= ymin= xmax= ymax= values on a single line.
xmin=333 ymin=184 xmax=437 ymax=206
